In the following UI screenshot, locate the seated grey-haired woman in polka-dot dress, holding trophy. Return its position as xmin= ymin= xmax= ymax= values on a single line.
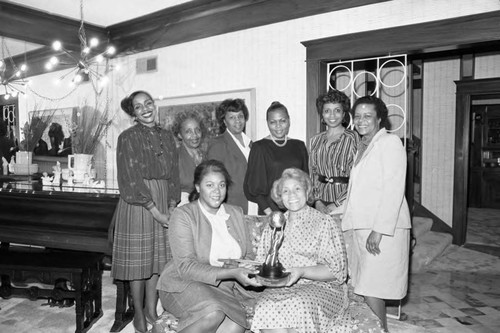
xmin=252 ymin=168 xmax=350 ymax=333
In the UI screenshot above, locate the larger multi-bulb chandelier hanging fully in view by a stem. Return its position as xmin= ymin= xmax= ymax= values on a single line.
xmin=45 ymin=0 xmax=116 ymax=86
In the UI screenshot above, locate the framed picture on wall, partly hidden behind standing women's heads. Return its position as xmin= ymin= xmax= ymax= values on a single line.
xmin=155 ymin=88 xmax=256 ymax=138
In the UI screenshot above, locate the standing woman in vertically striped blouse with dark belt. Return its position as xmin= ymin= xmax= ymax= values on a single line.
xmin=309 ymin=90 xmax=359 ymax=214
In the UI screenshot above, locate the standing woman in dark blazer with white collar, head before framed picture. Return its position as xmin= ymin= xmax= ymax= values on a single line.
xmin=207 ymin=98 xmax=257 ymax=215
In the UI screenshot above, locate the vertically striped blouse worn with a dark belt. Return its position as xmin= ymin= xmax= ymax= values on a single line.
xmin=309 ymin=129 xmax=359 ymax=207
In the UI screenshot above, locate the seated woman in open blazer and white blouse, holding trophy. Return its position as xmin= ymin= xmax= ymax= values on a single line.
xmin=158 ymin=160 xmax=259 ymax=333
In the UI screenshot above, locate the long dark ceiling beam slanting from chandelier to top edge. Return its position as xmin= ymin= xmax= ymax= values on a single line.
xmin=108 ymin=0 xmax=389 ymax=53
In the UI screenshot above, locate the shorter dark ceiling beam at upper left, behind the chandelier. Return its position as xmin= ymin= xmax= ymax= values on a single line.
xmin=0 ymin=2 xmax=108 ymax=52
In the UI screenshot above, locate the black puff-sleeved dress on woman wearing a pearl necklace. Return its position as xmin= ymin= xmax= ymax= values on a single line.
xmin=243 ymin=139 xmax=309 ymax=215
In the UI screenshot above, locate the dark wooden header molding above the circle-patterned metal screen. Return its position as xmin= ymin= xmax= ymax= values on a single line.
xmin=302 ymin=11 xmax=500 ymax=61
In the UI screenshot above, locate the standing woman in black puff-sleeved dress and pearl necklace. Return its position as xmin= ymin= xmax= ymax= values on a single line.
xmin=244 ymin=102 xmax=309 ymax=215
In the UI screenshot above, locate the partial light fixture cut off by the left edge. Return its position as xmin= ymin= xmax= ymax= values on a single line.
xmin=0 ymin=37 xmax=28 ymax=100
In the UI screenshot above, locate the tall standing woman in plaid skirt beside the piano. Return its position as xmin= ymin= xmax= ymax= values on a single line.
xmin=111 ymin=91 xmax=180 ymax=332
